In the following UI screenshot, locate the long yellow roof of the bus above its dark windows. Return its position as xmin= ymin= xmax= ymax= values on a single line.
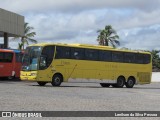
xmin=27 ymin=43 xmax=151 ymax=54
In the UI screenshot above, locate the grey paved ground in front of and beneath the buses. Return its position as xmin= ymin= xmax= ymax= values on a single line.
xmin=0 ymin=80 xmax=160 ymax=119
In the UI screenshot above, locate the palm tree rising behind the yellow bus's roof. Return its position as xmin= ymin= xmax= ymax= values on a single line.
xmin=97 ymin=25 xmax=120 ymax=48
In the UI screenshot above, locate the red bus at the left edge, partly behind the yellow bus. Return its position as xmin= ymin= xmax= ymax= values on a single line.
xmin=0 ymin=49 xmax=22 ymax=79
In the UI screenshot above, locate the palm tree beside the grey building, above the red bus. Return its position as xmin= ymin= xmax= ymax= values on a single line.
xmin=14 ymin=23 xmax=37 ymax=49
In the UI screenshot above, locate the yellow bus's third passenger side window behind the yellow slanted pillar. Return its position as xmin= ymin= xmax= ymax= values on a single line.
xmin=85 ymin=49 xmax=98 ymax=61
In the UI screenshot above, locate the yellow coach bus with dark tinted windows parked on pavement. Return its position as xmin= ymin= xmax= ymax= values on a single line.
xmin=20 ymin=44 xmax=152 ymax=88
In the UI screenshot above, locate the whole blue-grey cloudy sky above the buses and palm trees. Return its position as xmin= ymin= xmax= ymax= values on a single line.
xmin=0 ymin=0 xmax=160 ymax=50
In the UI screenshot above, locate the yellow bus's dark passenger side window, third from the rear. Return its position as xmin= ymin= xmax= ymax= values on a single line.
xmin=124 ymin=53 xmax=135 ymax=63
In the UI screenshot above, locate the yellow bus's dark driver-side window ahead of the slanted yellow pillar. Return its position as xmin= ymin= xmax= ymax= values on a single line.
xmin=42 ymin=46 xmax=55 ymax=67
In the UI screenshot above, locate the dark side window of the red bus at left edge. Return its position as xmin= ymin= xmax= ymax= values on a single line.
xmin=0 ymin=52 xmax=13 ymax=62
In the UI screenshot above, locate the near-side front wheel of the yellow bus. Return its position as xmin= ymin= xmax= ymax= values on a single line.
xmin=51 ymin=74 xmax=62 ymax=86
